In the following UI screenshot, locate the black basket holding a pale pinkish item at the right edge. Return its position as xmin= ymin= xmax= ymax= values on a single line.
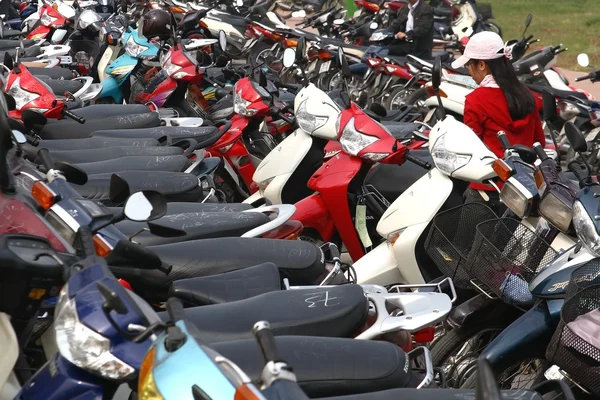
xmin=546 ymin=282 xmax=600 ymax=396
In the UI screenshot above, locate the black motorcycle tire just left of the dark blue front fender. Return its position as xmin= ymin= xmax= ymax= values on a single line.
xmin=431 ymin=319 xmax=512 ymax=389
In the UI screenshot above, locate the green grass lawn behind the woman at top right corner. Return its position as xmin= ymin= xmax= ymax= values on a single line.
xmin=480 ymin=0 xmax=600 ymax=70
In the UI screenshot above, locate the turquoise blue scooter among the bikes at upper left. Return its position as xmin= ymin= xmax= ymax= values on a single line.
xmin=99 ymin=27 xmax=159 ymax=104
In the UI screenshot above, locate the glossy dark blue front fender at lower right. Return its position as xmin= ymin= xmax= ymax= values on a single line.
xmin=481 ymin=301 xmax=559 ymax=366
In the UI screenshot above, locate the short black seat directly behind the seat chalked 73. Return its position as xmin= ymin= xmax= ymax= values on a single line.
xmin=169 ymin=263 xmax=281 ymax=306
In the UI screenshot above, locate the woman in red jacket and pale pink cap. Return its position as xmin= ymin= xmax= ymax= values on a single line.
xmin=452 ymin=32 xmax=546 ymax=211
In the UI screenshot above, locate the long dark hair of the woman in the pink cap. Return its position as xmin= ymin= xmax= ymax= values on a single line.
xmin=485 ymin=57 xmax=535 ymax=121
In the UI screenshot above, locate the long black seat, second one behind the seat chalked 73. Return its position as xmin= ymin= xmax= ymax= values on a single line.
xmin=111 ymin=238 xmax=325 ymax=301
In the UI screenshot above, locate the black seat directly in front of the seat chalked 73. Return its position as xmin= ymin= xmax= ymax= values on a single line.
xmin=212 ymin=336 xmax=412 ymax=400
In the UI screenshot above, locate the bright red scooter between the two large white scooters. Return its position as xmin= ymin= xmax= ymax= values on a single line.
xmin=292 ymin=102 xmax=430 ymax=261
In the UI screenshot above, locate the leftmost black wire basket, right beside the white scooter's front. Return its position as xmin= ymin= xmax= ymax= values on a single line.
xmin=425 ymin=203 xmax=498 ymax=289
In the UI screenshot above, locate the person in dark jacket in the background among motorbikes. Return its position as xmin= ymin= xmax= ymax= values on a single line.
xmin=388 ymin=0 xmax=433 ymax=60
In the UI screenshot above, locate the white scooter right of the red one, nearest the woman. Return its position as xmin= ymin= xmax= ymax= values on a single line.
xmin=353 ymin=59 xmax=574 ymax=285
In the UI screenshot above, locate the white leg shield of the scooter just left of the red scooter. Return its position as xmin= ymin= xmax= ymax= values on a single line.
xmin=252 ymin=129 xmax=313 ymax=204
